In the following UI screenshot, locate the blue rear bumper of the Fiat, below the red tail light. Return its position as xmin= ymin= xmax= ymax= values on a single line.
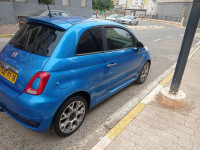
xmin=0 ymin=82 xmax=59 ymax=132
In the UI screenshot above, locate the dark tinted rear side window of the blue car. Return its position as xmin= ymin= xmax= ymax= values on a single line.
xmin=77 ymin=27 xmax=103 ymax=54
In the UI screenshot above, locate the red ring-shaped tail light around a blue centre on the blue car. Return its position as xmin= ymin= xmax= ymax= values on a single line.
xmin=24 ymin=71 xmax=50 ymax=95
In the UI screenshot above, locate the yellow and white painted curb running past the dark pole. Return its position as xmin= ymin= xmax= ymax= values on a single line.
xmin=92 ymin=41 xmax=200 ymax=150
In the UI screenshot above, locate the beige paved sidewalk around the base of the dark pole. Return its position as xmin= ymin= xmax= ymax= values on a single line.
xmin=93 ymin=47 xmax=200 ymax=150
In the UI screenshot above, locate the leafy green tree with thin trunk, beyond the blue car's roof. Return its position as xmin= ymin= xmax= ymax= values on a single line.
xmin=92 ymin=0 xmax=114 ymax=17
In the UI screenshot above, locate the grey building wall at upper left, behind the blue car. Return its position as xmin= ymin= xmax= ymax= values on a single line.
xmin=0 ymin=0 xmax=92 ymax=24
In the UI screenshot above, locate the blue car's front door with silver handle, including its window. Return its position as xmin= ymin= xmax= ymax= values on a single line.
xmin=104 ymin=26 xmax=141 ymax=92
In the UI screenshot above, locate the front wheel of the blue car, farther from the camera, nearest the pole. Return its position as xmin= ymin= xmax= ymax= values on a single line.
xmin=135 ymin=61 xmax=150 ymax=84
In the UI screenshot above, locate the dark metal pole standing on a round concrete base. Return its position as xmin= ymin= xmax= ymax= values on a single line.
xmin=169 ymin=0 xmax=200 ymax=94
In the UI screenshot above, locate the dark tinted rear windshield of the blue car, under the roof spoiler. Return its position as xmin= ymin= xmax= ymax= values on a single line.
xmin=10 ymin=24 xmax=65 ymax=57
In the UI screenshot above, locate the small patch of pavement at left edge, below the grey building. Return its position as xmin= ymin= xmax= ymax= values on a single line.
xmin=0 ymin=24 xmax=19 ymax=35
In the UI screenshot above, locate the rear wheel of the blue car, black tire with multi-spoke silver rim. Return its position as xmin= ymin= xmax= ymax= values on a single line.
xmin=52 ymin=96 xmax=88 ymax=137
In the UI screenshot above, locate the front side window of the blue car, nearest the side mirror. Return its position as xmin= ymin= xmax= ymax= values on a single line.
xmin=105 ymin=28 xmax=136 ymax=50
